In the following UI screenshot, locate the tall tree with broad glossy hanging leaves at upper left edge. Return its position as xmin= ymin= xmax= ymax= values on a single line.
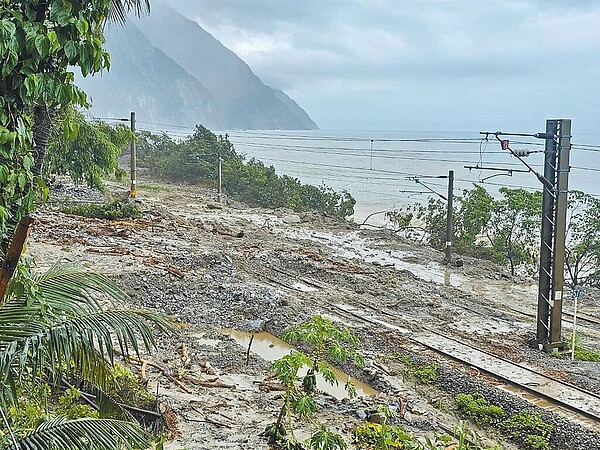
xmin=0 ymin=0 xmax=149 ymax=298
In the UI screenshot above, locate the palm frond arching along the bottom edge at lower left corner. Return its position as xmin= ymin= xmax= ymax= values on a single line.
xmin=4 ymin=418 xmax=150 ymax=450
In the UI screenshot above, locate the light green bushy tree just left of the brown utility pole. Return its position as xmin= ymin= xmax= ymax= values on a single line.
xmin=43 ymin=109 xmax=133 ymax=191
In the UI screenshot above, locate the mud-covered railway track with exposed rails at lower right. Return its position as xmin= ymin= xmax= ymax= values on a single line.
xmin=330 ymin=304 xmax=600 ymax=433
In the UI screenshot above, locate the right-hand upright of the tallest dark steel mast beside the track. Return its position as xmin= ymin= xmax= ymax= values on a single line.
xmin=549 ymin=119 xmax=571 ymax=348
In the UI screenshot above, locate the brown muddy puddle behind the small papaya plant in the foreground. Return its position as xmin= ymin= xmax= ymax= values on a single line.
xmin=222 ymin=329 xmax=379 ymax=400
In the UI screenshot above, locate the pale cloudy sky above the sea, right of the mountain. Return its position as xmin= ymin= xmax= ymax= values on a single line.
xmin=163 ymin=0 xmax=600 ymax=136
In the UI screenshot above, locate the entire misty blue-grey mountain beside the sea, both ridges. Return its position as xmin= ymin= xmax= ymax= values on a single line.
xmin=78 ymin=2 xmax=318 ymax=129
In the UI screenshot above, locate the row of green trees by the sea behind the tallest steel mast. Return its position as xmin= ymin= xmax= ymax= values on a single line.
xmin=388 ymin=186 xmax=600 ymax=286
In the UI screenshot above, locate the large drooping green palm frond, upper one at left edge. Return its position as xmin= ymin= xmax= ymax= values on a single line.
xmin=0 ymin=309 xmax=173 ymax=395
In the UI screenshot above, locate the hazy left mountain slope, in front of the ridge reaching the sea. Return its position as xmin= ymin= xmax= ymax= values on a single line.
xmin=78 ymin=23 xmax=224 ymax=128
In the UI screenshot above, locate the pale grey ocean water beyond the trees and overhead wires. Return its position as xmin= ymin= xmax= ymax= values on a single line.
xmin=227 ymin=130 xmax=600 ymax=224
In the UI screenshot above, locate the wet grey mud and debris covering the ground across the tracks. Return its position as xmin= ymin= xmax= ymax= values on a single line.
xmin=29 ymin=184 xmax=600 ymax=450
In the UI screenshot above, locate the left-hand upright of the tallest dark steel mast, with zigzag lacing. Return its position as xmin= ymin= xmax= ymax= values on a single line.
xmin=534 ymin=120 xmax=558 ymax=347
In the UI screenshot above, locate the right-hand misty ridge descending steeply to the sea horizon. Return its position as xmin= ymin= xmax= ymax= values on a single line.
xmin=136 ymin=2 xmax=317 ymax=129
